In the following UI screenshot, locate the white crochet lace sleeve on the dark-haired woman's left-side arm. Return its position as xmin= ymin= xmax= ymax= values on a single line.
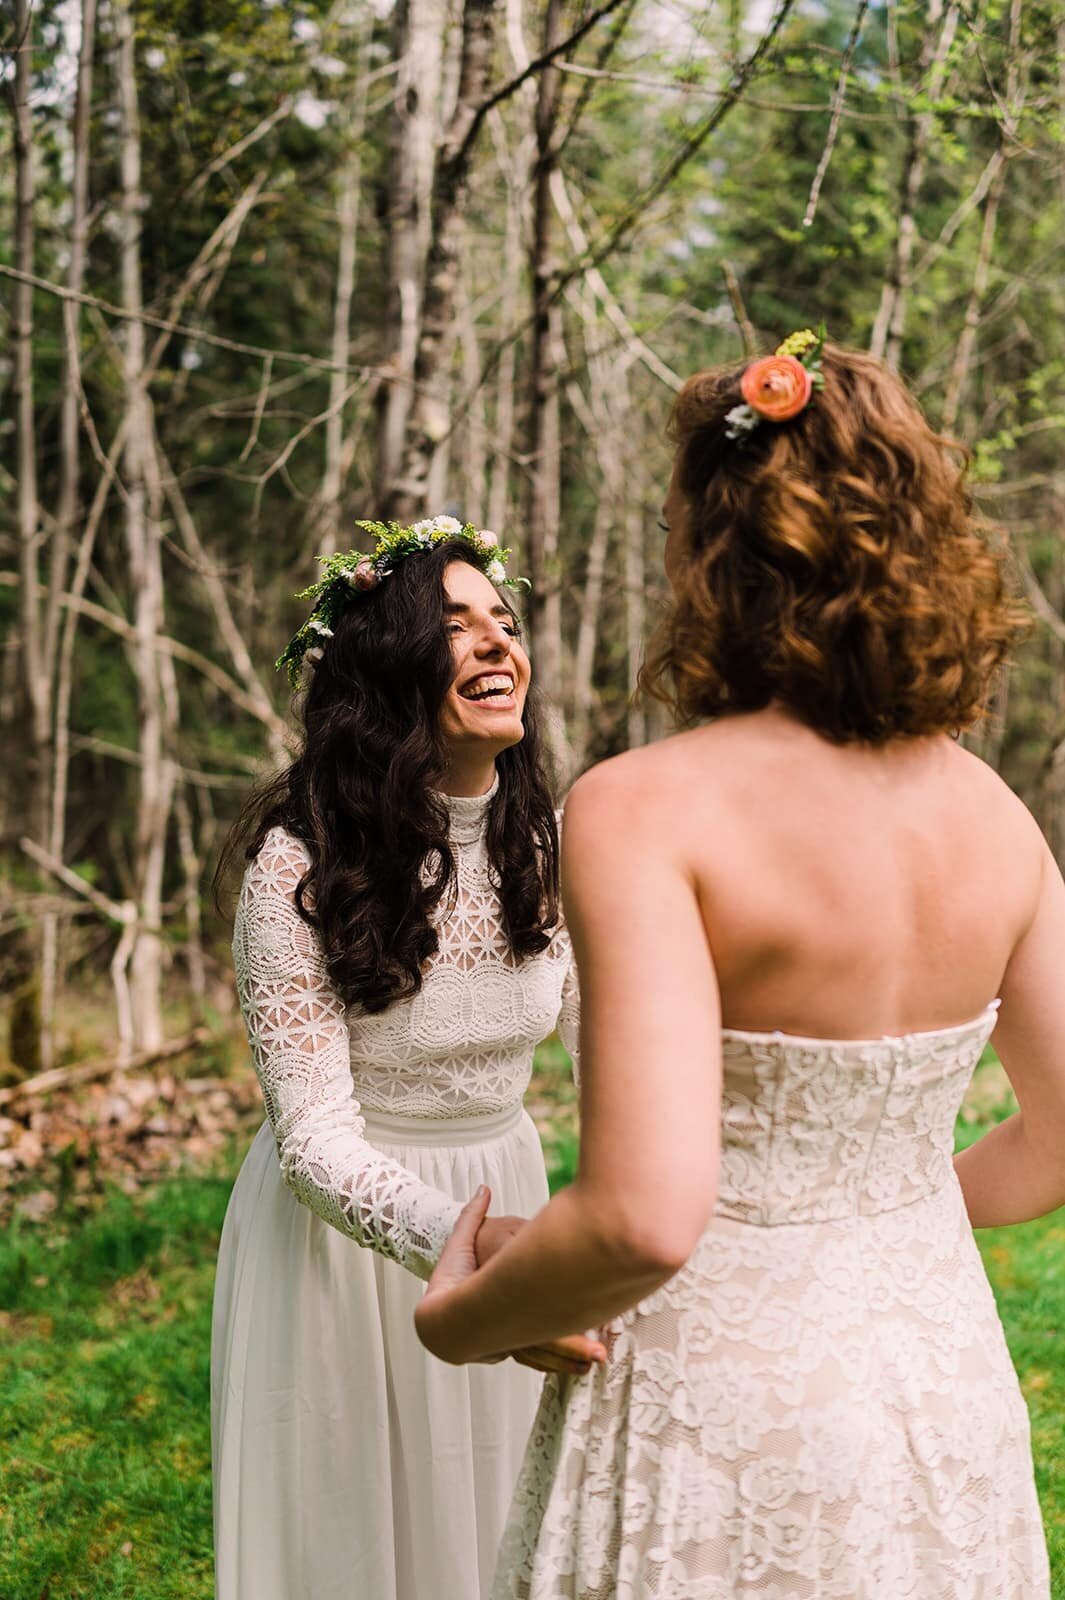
xmin=233 ymin=829 xmax=462 ymax=1278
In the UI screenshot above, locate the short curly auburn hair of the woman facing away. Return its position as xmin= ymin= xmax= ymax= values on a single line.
xmin=641 ymin=344 xmax=1025 ymax=744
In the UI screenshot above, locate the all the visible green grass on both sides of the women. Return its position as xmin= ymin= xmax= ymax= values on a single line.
xmin=0 ymin=1056 xmax=1065 ymax=1600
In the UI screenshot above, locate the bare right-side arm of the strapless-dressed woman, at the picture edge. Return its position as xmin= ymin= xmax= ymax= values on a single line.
xmin=955 ymin=842 xmax=1065 ymax=1227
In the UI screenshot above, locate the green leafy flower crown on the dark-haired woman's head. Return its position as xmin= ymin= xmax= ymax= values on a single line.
xmin=275 ymin=517 xmax=529 ymax=688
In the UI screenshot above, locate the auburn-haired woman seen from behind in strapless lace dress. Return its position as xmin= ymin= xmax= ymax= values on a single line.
xmin=416 ymin=333 xmax=1065 ymax=1600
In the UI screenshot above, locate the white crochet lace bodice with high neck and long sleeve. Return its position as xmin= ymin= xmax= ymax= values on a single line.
xmin=233 ymin=789 xmax=579 ymax=1277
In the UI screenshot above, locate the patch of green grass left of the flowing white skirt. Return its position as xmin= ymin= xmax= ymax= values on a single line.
xmin=0 ymin=1178 xmax=229 ymax=1600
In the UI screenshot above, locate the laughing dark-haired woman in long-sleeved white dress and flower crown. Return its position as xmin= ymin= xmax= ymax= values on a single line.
xmin=211 ymin=531 xmax=600 ymax=1600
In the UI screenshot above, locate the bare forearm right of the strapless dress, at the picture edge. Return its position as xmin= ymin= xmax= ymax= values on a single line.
xmin=955 ymin=1114 xmax=1065 ymax=1227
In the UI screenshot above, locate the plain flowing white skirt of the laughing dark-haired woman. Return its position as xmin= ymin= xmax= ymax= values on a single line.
xmin=211 ymin=1112 xmax=547 ymax=1600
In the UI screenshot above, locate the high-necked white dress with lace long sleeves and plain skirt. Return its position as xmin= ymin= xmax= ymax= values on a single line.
xmin=211 ymin=784 xmax=577 ymax=1600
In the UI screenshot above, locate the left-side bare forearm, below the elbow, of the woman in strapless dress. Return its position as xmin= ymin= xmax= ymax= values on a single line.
xmin=416 ymin=1184 xmax=678 ymax=1362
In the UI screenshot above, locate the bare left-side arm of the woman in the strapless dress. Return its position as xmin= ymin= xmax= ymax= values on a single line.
xmin=416 ymin=752 xmax=721 ymax=1362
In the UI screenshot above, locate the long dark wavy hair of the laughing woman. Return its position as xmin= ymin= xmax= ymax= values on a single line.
xmin=214 ymin=539 xmax=558 ymax=1011
